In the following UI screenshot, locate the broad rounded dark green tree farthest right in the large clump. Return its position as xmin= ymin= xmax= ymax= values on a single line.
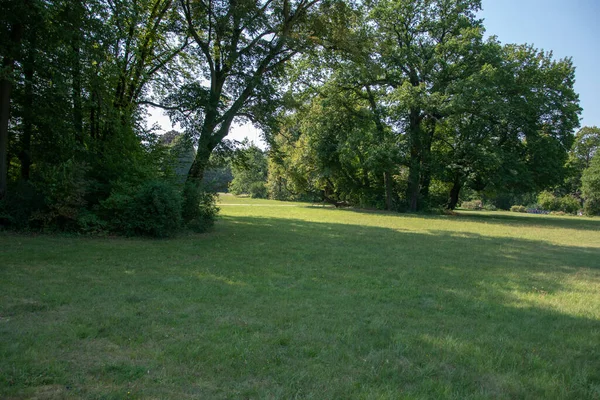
xmin=440 ymin=40 xmax=580 ymax=208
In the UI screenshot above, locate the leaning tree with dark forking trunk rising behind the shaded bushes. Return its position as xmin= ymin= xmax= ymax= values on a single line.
xmin=162 ymin=0 xmax=328 ymax=219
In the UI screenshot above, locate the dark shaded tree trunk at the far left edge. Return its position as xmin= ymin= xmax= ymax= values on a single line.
xmin=0 ymin=23 xmax=23 ymax=199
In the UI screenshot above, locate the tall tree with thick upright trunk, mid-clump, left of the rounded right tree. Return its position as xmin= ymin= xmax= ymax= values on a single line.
xmin=371 ymin=0 xmax=482 ymax=211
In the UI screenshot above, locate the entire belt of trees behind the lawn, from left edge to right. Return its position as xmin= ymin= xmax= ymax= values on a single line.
xmin=0 ymin=0 xmax=598 ymax=236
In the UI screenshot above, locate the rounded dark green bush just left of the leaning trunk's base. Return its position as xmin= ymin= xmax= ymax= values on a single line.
xmin=101 ymin=181 xmax=182 ymax=237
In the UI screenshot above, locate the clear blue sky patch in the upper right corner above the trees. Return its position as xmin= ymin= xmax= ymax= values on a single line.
xmin=481 ymin=0 xmax=600 ymax=127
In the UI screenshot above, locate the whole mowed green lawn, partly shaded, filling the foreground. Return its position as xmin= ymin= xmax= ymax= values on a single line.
xmin=0 ymin=196 xmax=600 ymax=399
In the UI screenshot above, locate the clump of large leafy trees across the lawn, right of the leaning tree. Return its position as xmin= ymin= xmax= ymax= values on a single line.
xmin=272 ymin=1 xmax=580 ymax=211
